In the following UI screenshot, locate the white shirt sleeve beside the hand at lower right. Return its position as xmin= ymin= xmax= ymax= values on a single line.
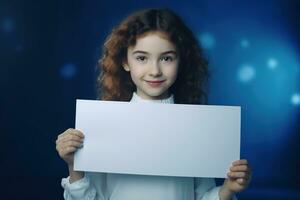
xmin=194 ymin=178 xmax=237 ymax=200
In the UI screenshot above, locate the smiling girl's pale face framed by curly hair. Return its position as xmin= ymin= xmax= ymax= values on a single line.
xmin=123 ymin=32 xmax=179 ymax=100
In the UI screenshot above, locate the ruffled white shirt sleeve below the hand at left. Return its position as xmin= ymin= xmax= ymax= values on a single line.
xmin=61 ymin=172 xmax=105 ymax=200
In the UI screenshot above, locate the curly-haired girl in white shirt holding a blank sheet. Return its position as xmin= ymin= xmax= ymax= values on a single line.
xmin=56 ymin=9 xmax=251 ymax=200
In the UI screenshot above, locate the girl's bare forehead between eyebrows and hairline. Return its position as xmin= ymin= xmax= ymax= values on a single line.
xmin=128 ymin=32 xmax=176 ymax=53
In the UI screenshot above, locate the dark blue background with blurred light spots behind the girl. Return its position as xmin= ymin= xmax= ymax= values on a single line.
xmin=0 ymin=0 xmax=300 ymax=200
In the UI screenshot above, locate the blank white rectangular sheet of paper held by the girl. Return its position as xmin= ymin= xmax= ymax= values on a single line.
xmin=74 ymin=100 xmax=241 ymax=178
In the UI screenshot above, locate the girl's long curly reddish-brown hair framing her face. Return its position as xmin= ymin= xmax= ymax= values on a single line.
xmin=97 ymin=9 xmax=208 ymax=104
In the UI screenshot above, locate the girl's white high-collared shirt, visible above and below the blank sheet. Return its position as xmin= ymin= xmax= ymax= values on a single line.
xmin=61 ymin=93 xmax=236 ymax=200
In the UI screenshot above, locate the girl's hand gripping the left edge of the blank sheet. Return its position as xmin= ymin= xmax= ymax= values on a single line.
xmin=55 ymin=128 xmax=84 ymax=167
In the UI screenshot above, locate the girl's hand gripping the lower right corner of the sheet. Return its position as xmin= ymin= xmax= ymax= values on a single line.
xmin=221 ymin=159 xmax=252 ymax=197
